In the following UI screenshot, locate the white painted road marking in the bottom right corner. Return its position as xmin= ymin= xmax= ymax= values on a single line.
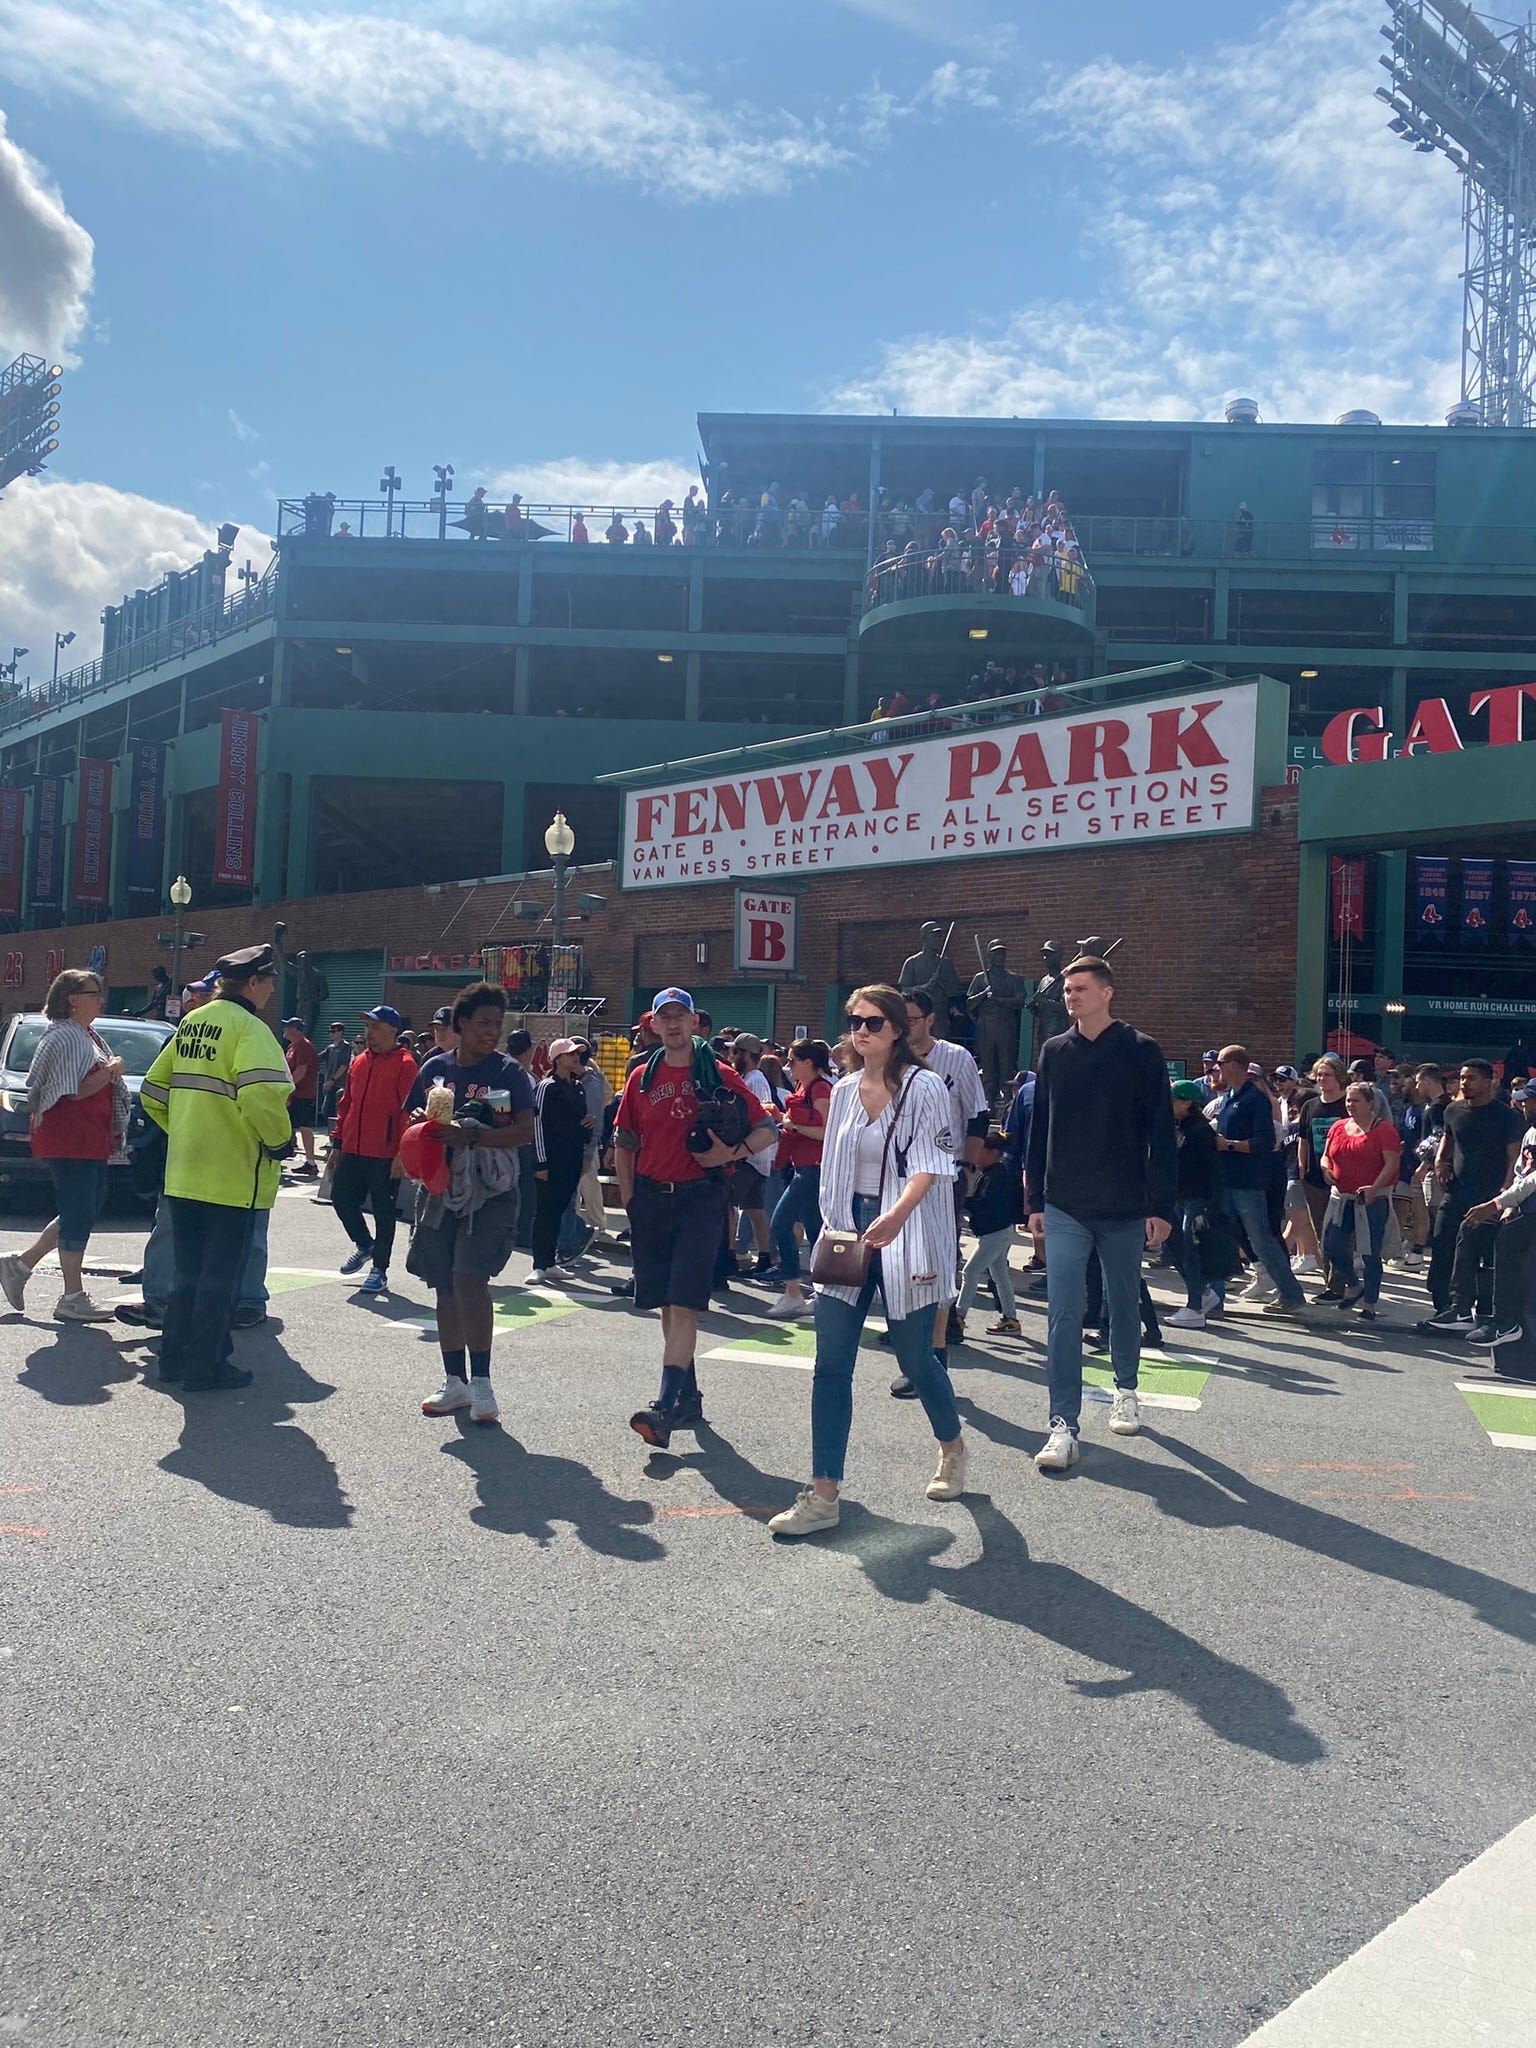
xmin=1243 ymin=1821 xmax=1536 ymax=2048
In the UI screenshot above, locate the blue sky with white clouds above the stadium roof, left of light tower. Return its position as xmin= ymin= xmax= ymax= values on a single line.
xmin=0 ymin=0 xmax=1458 ymax=647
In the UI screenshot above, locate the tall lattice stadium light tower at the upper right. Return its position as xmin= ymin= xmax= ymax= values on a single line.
xmin=1376 ymin=0 xmax=1536 ymax=426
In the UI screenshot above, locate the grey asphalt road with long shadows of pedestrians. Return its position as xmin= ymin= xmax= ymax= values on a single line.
xmin=0 ymin=1194 xmax=1536 ymax=2048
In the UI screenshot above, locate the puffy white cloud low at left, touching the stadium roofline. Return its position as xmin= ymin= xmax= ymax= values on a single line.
xmin=0 ymin=477 xmax=272 ymax=655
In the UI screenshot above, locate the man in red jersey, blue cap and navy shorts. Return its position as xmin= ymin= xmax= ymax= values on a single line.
xmin=614 ymin=989 xmax=778 ymax=1450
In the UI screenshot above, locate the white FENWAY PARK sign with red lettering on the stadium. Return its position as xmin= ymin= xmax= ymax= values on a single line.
xmin=623 ymin=684 xmax=1257 ymax=889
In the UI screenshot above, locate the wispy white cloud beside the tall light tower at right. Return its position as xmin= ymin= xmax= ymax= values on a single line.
xmin=829 ymin=0 xmax=1462 ymax=420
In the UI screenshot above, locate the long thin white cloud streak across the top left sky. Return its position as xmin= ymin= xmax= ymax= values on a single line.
xmin=0 ymin=0 xmax=844 ymax=199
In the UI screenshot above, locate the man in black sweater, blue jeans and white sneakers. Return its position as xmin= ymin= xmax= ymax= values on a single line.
xmin=1024 ymin=956 xmax=1178 ymax=1473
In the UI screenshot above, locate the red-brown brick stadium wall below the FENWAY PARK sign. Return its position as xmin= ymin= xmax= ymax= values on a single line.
xmin=18 ymin=786 xmax=1315 ymax=1071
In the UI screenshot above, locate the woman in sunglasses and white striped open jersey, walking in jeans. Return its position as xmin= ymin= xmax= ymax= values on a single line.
xmin=768 ymin=983 xmax=965 ymax=1536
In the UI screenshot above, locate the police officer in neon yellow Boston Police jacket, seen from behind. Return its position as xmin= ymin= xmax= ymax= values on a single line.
xmin=139 ymin=946 xmax=293 ymax=1393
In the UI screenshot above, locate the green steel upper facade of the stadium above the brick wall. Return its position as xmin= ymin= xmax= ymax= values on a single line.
xmin=12 ymin=408 xmax=1536 ymax=1051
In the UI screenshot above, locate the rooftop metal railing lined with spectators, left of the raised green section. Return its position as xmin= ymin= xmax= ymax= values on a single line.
xmin=276 ymin=492 xmax=868 ymax=555
